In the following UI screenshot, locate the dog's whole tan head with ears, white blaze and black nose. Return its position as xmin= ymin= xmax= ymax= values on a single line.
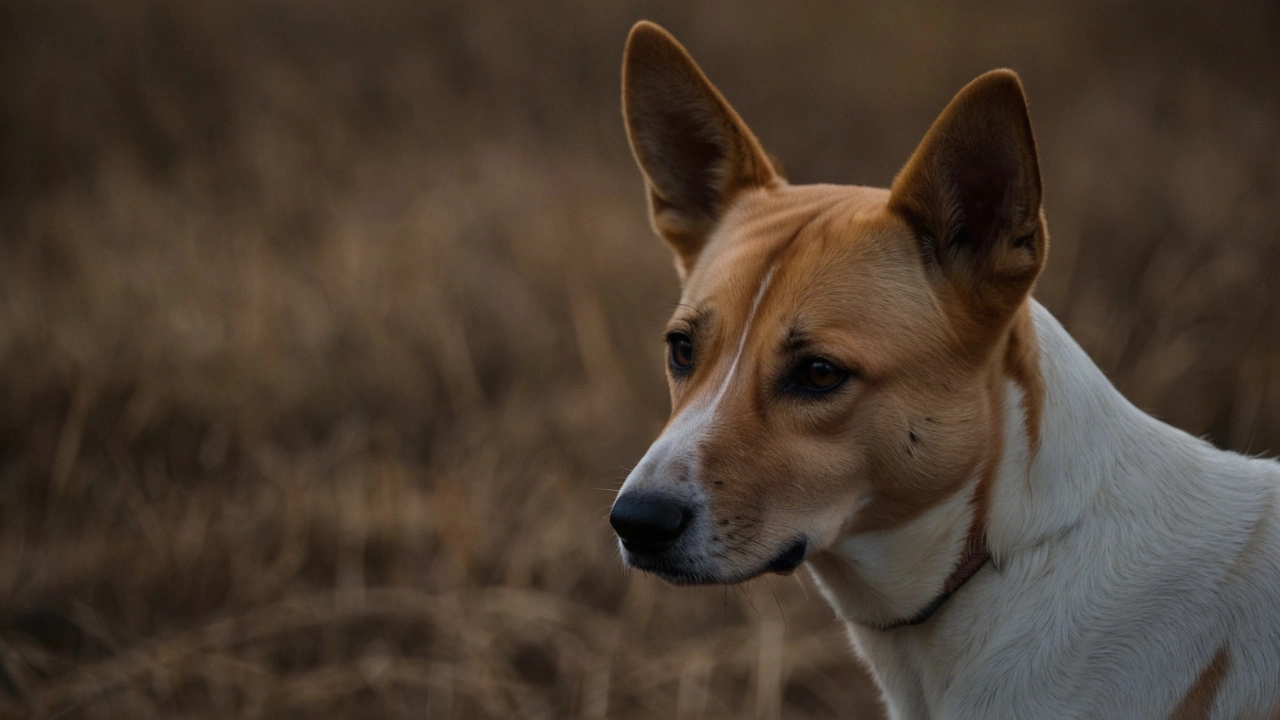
xmin=611 ymin=23 xmax=1048 ymax=583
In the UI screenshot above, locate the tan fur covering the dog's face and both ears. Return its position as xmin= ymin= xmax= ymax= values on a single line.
xmin=623 ymin=23 xmax=1047 ymax=550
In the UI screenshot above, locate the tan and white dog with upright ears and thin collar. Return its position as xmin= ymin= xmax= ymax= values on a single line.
xmin=609 ymin=22 xmax=1280 ymax=720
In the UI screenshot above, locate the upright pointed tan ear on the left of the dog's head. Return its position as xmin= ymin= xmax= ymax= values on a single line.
xmin=622 ymin=22 xmax=781 ymax=281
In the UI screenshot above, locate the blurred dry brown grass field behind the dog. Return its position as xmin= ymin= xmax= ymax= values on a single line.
xmin=0 ymin=0 xmax=1280 ymax=719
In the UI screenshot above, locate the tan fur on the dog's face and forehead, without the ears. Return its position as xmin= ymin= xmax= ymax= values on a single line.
xmin=672 ymin=181 xmax=1002 ymax=540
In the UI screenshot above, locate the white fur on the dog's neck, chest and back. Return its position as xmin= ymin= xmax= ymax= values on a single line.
xmin=814 ymin=298 xmax=1280 ymax=720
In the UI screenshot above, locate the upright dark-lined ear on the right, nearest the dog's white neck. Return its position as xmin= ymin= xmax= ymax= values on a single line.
xmin=890 ymin=70 xmax=1048 ymax=329
